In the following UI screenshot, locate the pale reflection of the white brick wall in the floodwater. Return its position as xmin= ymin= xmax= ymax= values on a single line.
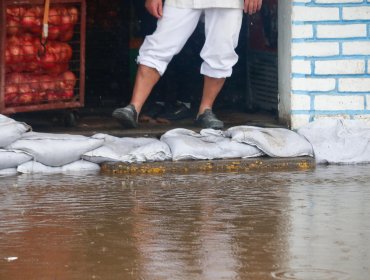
xmin=289 ymin=166 xmax=370 ymax=279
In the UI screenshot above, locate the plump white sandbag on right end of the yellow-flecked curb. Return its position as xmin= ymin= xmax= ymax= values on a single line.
xmin=225 ymin=126 xmax=313 ymax=157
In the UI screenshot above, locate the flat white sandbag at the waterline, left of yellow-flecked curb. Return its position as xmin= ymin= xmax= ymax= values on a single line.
xmin=17 ymin=160 xmax=100 ymax=174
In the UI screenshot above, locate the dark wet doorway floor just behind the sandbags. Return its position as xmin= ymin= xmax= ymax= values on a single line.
xmin=11 ymin=108 xmax=284 ymax=137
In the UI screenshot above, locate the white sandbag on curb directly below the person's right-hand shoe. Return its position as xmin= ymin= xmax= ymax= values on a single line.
xmin=161 ymin=128 xmax=263 ymax=160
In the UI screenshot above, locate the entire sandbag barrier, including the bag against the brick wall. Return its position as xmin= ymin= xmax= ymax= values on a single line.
xmin=0 ymin=114 xmax=370 ymax=175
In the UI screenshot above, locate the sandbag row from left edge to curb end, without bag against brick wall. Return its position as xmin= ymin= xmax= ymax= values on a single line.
xmin=0 ymin=112 xmax=313 ymax=175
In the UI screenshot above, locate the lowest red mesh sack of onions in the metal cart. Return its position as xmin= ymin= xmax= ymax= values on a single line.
xmin=4 ymin=71 xmax=77 ymax=106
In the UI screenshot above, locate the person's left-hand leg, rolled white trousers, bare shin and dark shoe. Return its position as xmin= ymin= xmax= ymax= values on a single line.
xmin=113 ymin=6 xmax=201 ymax=127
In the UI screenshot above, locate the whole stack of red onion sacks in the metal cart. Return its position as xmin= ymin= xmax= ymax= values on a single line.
xmin=4 ymin=5 xmax=79 ymax=106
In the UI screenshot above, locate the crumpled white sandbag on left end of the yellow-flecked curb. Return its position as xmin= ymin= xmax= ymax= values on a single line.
xmin=82 ymin=134 xmax=171 ymax=163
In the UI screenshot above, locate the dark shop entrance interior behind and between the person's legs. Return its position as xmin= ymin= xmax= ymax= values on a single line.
xmin=86 ymin=0 xmax=278 ymax=127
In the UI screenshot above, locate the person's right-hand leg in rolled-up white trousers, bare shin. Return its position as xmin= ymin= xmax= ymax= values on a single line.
xmin=198 ymin=8 xmax=243 ymax=127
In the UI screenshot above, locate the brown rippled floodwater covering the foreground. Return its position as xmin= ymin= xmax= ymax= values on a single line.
xmin=0 ymin=166 xmax=370 ymax=280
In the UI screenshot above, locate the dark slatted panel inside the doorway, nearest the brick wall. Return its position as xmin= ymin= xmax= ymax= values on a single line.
xmin=247 ymin=0 xmax=278 ymax=111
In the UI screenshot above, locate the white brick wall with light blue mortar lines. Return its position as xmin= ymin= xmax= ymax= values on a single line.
xmin=290 ymin=0 xmax=370 ymax=129
